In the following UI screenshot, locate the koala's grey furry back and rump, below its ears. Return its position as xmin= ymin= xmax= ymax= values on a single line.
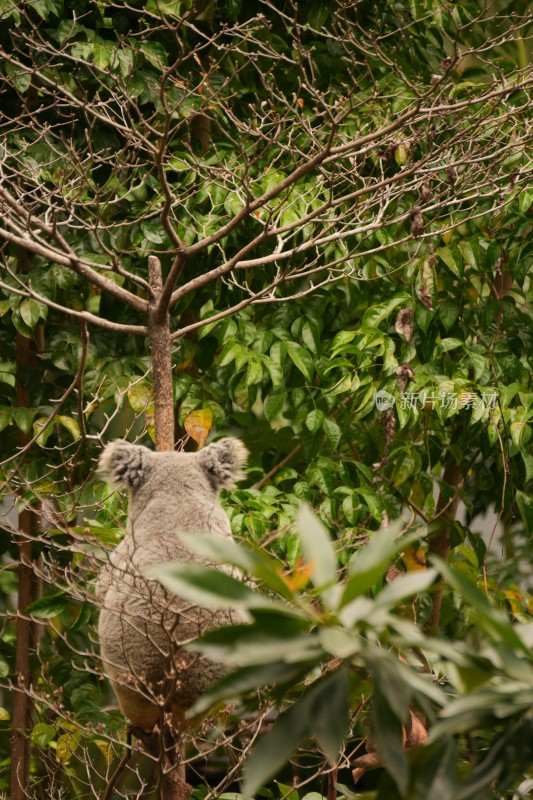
xmin=97 ymin=438 xmax=248 ymax=729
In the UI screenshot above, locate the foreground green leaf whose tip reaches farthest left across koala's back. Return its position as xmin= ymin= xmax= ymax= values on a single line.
xmin=143 ymin=562 xmax=275 ymax=608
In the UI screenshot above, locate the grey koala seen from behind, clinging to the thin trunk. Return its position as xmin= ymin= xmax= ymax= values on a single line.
xmin=96 ymin=437 xmax=248 ymax=730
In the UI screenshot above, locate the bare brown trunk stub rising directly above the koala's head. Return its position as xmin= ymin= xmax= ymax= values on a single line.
xmin=148 ymin=256 xmax=174 ymax=450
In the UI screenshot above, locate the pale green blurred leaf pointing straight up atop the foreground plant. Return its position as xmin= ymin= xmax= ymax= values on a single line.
xmin=296 ymin=503 xmax=337 ymax=599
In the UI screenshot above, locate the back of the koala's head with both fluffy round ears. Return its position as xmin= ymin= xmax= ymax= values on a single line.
xmin=98 ymin=436 xmax=248 ymax=493
